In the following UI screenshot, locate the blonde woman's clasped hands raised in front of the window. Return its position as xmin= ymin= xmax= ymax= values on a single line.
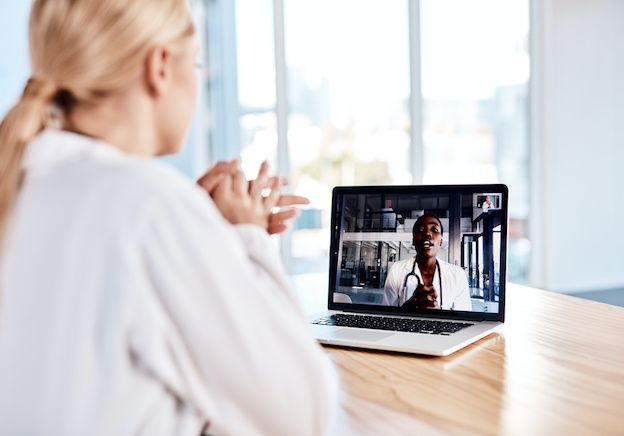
xmin=197 ymin=159 xmax=310 ymax=234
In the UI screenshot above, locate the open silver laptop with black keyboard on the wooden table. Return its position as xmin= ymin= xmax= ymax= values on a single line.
xmin=308 ymin=184 xmax=508 ymax=356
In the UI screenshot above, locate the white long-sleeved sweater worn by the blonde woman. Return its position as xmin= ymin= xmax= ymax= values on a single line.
xmin=0 ymin=130 xmax=337 ymax=436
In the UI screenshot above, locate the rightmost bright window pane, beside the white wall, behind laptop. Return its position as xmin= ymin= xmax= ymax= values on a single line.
xmin=420 ymin=0 xmax=529 ymax=281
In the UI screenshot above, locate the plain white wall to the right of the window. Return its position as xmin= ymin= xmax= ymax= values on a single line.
xmin=531 ymin=0 xmax=624 ymax=292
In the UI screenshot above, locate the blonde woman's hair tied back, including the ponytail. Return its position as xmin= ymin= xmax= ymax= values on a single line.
xmin=0 ymin=0 xmax=195 ymax=243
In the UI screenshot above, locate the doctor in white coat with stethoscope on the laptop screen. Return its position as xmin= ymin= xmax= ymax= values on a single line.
xmin=384 ymin=214 xmax=472 ymax=310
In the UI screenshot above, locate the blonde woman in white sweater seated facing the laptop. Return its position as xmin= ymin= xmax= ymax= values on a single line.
xmin=0 ymin=0 xmax=336 ymax=436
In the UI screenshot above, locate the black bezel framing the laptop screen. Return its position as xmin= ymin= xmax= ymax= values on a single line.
xmin=327 ymin=184 xmax=509 ymax=322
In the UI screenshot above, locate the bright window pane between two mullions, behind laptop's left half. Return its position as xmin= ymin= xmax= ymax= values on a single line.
xmin=284 ymin=0 xmax=411 ymax=273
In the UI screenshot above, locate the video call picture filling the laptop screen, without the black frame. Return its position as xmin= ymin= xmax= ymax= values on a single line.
xmin=333 ymin=192 xmax=503 ymax=313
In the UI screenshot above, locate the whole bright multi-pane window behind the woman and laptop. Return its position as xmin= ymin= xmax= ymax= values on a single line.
xmin=208 ymin=0 xmax=529 ymax=281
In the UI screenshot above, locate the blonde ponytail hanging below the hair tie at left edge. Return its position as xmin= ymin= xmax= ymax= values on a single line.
xmin=0 ymin=78 xmax=57 ymax=240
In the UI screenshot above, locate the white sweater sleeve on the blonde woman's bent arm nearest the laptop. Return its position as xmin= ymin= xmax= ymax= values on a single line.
xmin=134 ymin=186 xmax=337 ymax=435
